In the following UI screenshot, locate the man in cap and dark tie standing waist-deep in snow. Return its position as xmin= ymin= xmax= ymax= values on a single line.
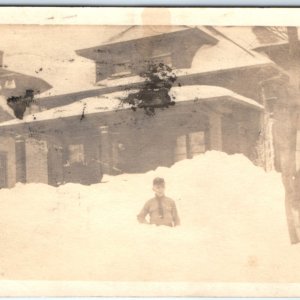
xmin=137 ymin=177 xmax=180 ymax=227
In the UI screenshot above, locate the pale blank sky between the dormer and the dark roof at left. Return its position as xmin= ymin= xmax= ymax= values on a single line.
xmin=0 ymin=25 xmax=124 ymax=95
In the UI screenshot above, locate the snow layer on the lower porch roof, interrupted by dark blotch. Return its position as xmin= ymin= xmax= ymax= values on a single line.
xmin=0 ymin=85 xmax=263 ymax=127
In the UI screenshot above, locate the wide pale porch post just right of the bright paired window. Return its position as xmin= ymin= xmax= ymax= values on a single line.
xmin=209 ymin=112 xmax=222 ymax=151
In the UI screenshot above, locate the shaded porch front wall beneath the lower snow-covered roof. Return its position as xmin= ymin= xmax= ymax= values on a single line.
xmin=4 ymin=97 xmax=260 ymax=186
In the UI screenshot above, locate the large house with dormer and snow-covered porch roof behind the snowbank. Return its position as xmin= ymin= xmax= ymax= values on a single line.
xmin=0 ymin=26 xmax=280 ymax=186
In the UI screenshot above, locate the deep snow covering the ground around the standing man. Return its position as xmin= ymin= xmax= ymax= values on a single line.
xmin=0 ymin=151 xmax=300 ymax=282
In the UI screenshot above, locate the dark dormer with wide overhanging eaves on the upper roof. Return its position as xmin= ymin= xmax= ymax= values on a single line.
xmin=76 ymin=26 xmax=217 ymax=81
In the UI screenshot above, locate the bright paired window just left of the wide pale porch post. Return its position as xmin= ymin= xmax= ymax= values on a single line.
xmin=175 ymin=131 xmax=206 ymax=161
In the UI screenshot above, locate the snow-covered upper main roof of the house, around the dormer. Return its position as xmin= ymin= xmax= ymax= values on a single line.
xmin=28 ymin=26 xmax=277 ymax=112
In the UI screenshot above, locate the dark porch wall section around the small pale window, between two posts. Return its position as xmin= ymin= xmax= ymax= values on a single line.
xmin=45 ymin=123 xmax=103 ymax=186
